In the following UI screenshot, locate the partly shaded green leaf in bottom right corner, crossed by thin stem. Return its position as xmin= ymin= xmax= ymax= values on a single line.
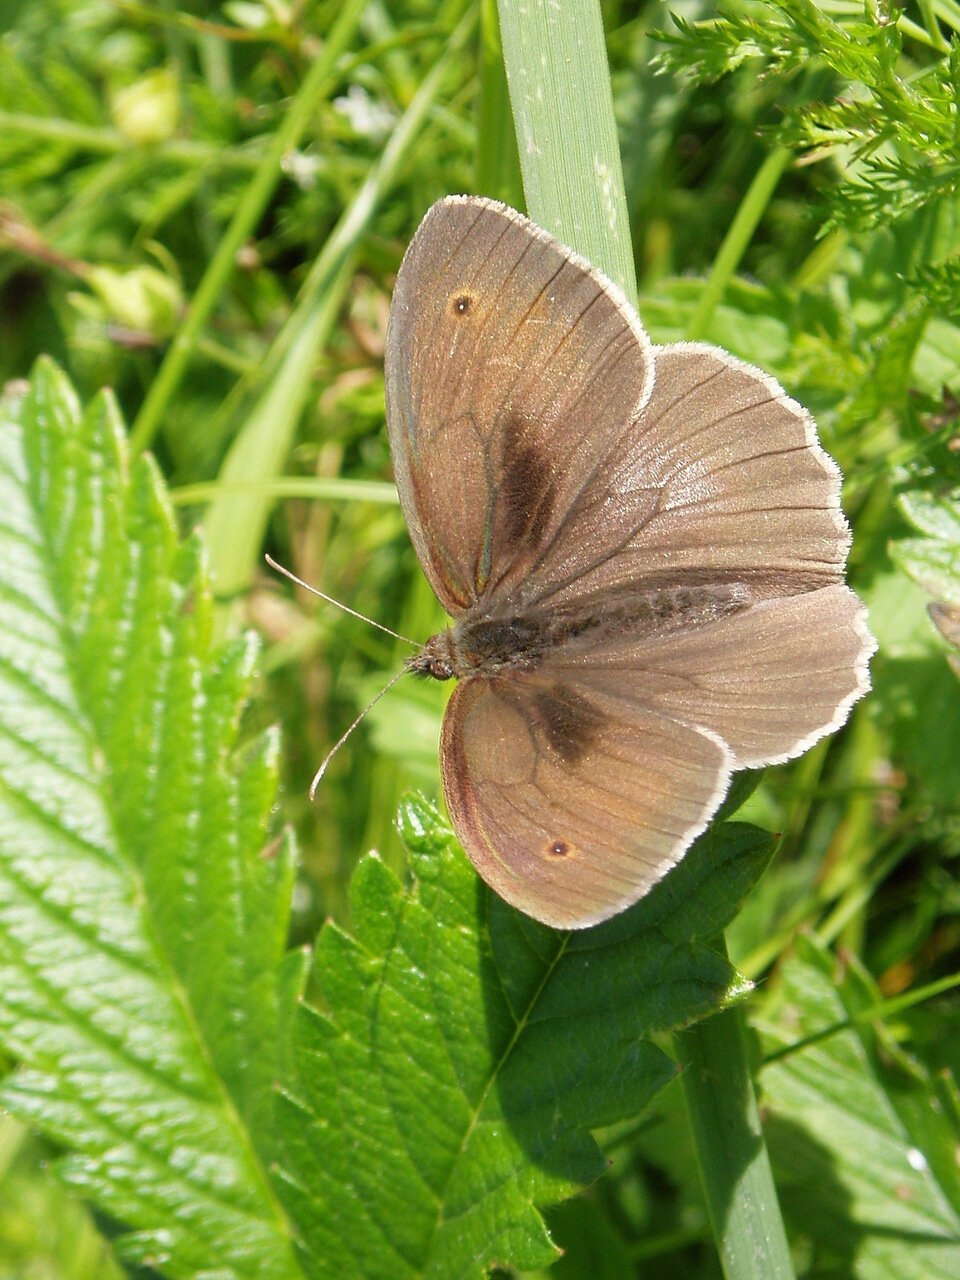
xmin=760 ymin=940 xmax=960 ymax=1280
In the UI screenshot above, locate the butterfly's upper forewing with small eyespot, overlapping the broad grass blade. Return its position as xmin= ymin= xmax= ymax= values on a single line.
xmin=384 ymin=197 xmax=652 ymax=617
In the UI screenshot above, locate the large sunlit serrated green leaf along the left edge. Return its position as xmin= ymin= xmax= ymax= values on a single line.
xmin=0 ymin=362 xmax=298 ymax=1280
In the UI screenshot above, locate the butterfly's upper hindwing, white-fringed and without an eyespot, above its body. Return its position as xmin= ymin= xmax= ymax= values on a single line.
xmin=514 ymin=343 xmax=850 ymax=607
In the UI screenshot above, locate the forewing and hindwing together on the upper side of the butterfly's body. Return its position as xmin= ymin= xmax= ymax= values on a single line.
xmin=385 ymin=207 xmax=849 ymax=617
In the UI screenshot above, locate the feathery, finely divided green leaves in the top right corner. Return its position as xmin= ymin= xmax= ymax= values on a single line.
xmin=660 ymin=0 xmax=960 ymax=230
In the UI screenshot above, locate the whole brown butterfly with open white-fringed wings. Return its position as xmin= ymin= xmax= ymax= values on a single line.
xmin=385 ymin=196 xmax=874 ymax=928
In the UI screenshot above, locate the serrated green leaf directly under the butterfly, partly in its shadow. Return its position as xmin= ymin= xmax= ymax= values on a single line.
xmin=282 ymin=801 xmax=772 ymax=1280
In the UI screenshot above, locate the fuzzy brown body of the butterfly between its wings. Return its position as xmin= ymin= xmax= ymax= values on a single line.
xmin=407 ymin=582 xmax=750 ymax=680
